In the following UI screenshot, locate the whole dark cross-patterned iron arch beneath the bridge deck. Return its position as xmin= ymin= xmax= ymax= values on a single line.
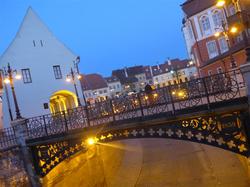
xmin=28 ymin=112 xmax=249 ymax=176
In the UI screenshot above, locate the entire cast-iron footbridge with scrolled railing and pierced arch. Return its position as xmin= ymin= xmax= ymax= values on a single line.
xmin=0 ymin=70 xmax=250 ymax=176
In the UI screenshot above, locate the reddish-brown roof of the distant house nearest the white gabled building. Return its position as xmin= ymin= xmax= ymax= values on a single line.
xmin=80 ymin=74 xmax=108 ymax=90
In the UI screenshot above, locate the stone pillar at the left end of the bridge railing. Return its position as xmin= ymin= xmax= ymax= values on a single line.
xmin=11 ymin=118 xmax=41 ymax=187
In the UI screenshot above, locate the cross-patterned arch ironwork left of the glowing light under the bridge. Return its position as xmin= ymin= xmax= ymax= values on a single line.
xmin=32 ymin=139 xmax=86 ymax=176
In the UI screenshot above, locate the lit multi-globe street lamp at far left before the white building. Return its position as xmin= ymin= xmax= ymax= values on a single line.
xmin=1 ymin=63 xmax=22 ymax=120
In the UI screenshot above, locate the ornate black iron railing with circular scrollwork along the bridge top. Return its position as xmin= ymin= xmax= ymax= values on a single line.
xmin=0 ymin=70 xmax=245 ymax=149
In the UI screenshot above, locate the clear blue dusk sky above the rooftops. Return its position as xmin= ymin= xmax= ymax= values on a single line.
xmin=0 ymin=0 xmax=187 ymax=76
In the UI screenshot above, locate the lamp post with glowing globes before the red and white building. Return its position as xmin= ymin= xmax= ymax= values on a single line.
xmin=214 ymin=0 xmax=238 ymax=71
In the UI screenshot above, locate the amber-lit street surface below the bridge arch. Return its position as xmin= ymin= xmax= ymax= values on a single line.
xmin=43 ymin=139 xmax=250 ymax=187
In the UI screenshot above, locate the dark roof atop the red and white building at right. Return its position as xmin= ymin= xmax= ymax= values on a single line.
xmin=181 ymin=0 xmax=217 ymax=17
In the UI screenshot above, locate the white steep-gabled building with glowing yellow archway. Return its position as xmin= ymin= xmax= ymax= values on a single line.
xmin=0 ymin=8 xmax=82 ymax=126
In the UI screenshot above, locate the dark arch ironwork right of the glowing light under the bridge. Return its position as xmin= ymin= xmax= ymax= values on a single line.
xmin=97 ymin=112 xmax=249 ymax=156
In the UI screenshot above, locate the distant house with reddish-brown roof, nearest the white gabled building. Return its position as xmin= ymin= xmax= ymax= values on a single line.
xmin=81 ymin=73 xmax=110 ymax=103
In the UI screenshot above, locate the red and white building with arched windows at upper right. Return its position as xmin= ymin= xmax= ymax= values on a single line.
xmin=182 ymin=0 xmax=250 ymax=76
